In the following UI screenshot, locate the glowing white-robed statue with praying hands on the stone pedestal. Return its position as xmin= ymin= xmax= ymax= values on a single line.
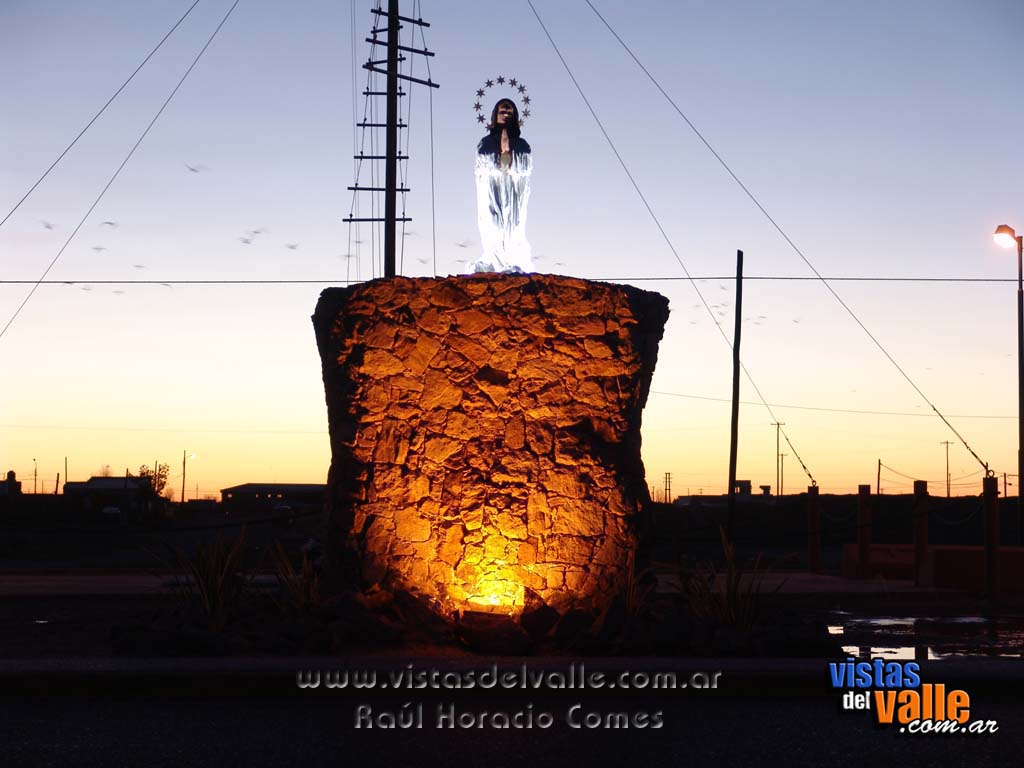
xmin=469 ymin=97 xmax=534 ymax=272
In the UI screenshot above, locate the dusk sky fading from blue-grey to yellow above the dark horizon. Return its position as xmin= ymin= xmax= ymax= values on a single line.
xmin=0 ymin=0 xmax=1024 ymax=498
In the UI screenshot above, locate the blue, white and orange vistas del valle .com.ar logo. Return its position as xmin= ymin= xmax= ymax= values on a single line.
xmin=828 ymin=657 xmax=999 ymax=735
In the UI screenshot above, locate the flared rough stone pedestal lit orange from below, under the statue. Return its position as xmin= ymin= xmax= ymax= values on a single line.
xmin=313 ymin=274 xmax=669 ymax=616
